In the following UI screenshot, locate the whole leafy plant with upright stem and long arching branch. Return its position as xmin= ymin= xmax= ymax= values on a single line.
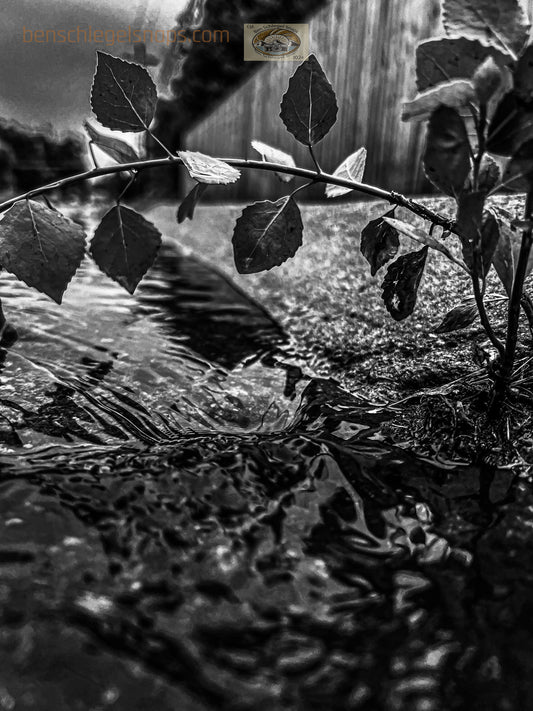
xmin=0 ymin=0 xmax=533 ymax=418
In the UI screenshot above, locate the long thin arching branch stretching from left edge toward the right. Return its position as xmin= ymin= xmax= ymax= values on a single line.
xmin=0 ymin=156 xmax=456 ymax=233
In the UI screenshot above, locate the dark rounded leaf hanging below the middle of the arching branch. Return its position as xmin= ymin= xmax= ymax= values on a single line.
xmin=232 ymin=195 xmax=303 ymax=274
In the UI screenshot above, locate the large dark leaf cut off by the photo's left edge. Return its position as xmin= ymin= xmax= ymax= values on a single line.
xmin=0 ymin=200 xmax=85 ymax=304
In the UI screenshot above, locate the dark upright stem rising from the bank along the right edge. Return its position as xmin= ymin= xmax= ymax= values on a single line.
xmin=491 ymin=188 xmax=533 ymax=415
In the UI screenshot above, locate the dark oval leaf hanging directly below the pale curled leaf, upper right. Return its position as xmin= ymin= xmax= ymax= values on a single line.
xmin=423 ymin=106 xmax=470 ymax=196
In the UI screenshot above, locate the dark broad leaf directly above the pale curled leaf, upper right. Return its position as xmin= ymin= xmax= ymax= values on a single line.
xmin=416 ymin=37 xmax=511 ymax=91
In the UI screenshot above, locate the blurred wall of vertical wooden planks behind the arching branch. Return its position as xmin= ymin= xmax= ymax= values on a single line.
xmin=186 ymin=0 xmax=442 ymax=200
